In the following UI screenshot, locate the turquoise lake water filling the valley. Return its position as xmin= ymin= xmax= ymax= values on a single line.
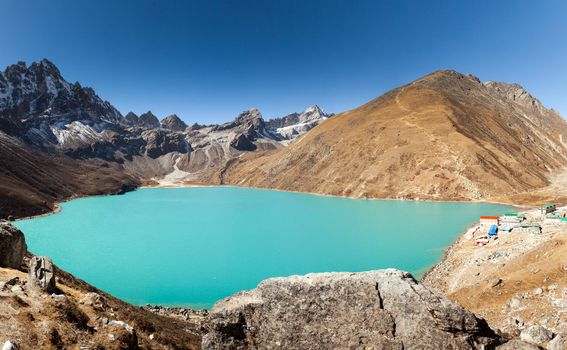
xmin=16 ymin=187 xmax=510 ymax=308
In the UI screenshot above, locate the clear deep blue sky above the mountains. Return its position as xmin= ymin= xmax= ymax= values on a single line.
xmin=0 ymin=0 xmax=567 ymax=123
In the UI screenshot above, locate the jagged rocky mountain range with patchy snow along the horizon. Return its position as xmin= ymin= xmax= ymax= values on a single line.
xmin=0 ymin=60 xmax=328 ymax=163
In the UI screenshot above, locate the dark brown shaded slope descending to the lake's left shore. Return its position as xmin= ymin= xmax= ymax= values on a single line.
xmin=0 ymin=132 xmax=140 ymax=218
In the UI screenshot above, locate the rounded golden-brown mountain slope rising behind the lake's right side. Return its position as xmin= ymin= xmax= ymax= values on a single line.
xmin=213 ymin=71 xmax=567 ymax=200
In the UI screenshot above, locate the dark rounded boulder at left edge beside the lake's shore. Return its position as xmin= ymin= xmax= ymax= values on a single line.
xmin=0 ymin=221 xmax=28 ymax=269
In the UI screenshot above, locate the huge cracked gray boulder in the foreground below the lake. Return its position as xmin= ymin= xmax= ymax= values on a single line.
xmin=202 ymin=269 xmax=500 ymax=350
